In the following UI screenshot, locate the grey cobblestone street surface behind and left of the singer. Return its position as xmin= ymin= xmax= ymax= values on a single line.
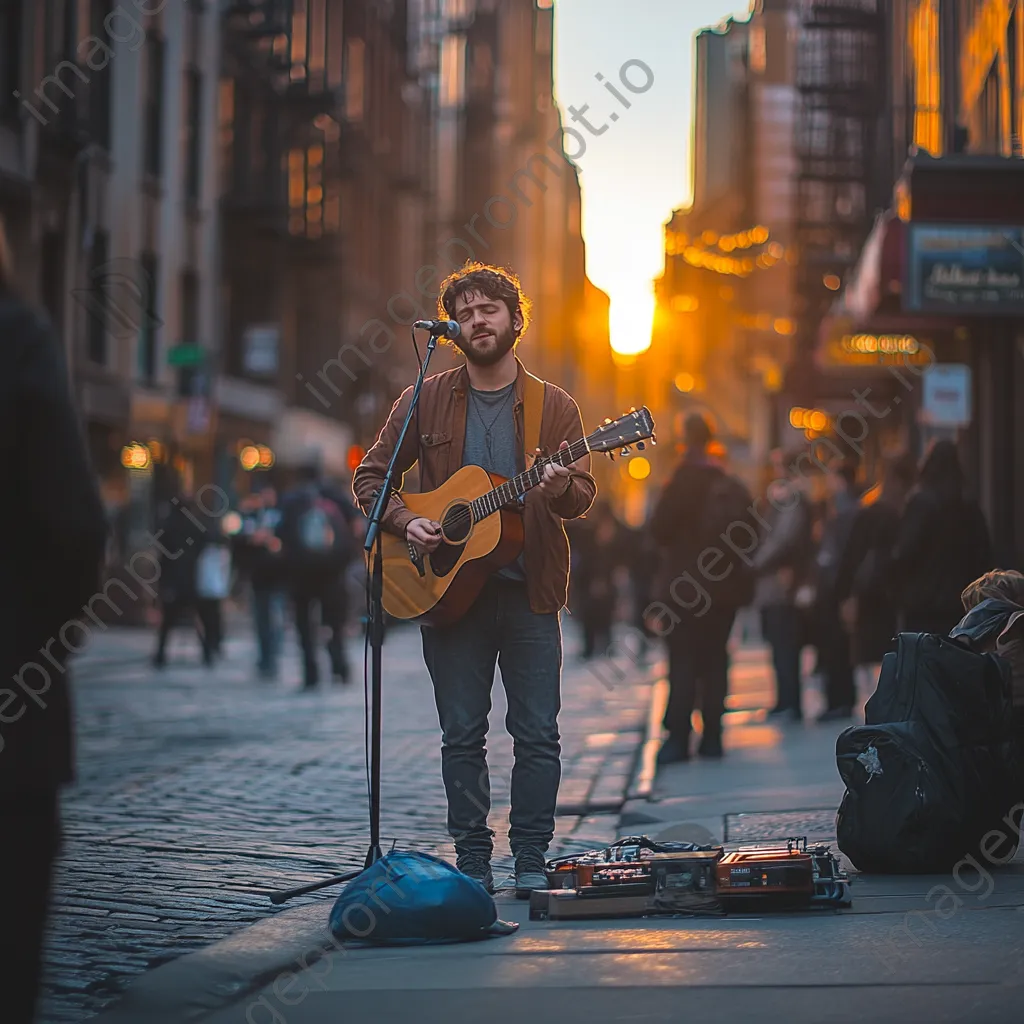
xmin=42 ymin=617 xmax=650 ymax=1024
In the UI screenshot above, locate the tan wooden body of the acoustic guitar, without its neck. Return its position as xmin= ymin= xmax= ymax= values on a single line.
xmin=380 ymin=466 xmax=523 ymax=626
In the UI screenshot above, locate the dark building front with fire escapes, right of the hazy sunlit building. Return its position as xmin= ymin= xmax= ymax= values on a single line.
xmin=788 ymin=0 xmax=886 ymax=391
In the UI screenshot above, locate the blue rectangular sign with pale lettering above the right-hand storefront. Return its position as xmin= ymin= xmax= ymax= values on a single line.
xmin=904 ymin=223 xmax=1024 ymax=315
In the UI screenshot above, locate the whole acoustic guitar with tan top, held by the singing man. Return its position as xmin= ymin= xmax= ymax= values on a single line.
xmin=380 ymin=407 xmax=656 ymax=626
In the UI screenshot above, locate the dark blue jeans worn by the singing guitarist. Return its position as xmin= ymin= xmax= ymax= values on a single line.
xmin=422 ymin=578 xmax=562 ymax=857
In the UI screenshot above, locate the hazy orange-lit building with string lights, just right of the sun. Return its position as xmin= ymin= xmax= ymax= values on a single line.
xmin=647 ymin=0 xmax=799 ymax=491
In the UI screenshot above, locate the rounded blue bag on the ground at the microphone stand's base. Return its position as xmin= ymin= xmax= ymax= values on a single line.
xmin=331 ymin=850 xmax=518 ymax=944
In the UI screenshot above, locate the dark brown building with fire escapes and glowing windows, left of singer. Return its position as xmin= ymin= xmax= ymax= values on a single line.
xmin=220 ymin=0 xmax=352 ymax=385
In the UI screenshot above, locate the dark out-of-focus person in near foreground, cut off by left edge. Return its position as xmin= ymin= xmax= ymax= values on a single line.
xmin=0 ymin=222 xmax=106 ymax=1024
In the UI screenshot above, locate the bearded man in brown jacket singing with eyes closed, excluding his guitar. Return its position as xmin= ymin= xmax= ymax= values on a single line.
xmin=352 ymin=263 xmax=597 ymax=898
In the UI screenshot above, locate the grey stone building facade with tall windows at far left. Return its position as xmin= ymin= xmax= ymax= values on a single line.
xmin=0 ymin=0 xmax=219 ymax=561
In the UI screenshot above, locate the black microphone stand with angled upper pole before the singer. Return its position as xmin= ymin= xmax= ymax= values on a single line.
xmin=270 ymin=322 xmax=446 ymax=905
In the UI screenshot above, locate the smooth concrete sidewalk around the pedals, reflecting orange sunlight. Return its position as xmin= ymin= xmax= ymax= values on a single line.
xmin=92 ymin=648 xmax=1024 ymax=1024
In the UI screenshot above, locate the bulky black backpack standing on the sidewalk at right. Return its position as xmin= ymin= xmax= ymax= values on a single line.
xmin=836 ymin=633 xmax=1022 ymax=873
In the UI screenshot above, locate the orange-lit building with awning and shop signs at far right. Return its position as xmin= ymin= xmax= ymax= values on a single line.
xmin=820 ymin=0 xmax=1024 ymax=567
